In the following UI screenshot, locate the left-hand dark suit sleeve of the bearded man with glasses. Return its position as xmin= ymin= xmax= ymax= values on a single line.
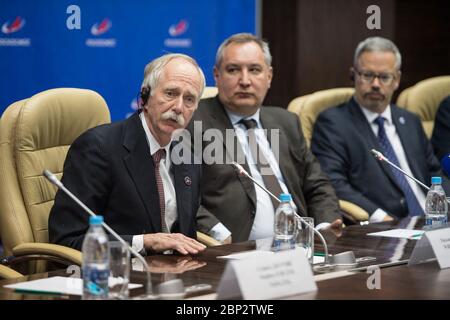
xmin=311 ymin=113 xmax=378 ymax=214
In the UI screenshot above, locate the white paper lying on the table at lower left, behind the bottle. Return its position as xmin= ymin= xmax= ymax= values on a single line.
xmin=4 ymin=277 xmax=142 ymax=296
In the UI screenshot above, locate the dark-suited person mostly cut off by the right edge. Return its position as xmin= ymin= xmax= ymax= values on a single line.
xmin=431 ymin=96 xmax=450 ymax=160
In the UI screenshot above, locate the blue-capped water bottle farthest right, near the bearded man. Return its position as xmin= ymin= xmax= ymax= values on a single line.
xmin=425 ymin=177 xmax=448 ymax=229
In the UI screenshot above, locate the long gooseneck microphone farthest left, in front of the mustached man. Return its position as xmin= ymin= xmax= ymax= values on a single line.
xmin=43 ymin=170 xmax=158 ymax=299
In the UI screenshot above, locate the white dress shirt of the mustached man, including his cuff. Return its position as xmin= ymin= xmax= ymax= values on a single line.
xmin=132 ymin=113 xmax=178 ymax=252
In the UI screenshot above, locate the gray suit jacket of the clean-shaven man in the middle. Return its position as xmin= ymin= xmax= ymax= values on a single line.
xmin=188 ymin=97 xmax=341 ymax=242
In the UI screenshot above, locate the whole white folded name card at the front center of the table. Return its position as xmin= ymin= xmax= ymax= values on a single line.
xmin=217 ymin=249 xmax=317 ymax=300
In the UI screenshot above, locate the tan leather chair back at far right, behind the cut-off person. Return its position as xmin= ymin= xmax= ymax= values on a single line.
xmin=397 ymin=76 xmax=450 ymax=138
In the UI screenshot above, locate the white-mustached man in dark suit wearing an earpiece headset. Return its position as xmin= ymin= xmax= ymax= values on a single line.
xmin=49 ymin=54 xmax=205 ymax=254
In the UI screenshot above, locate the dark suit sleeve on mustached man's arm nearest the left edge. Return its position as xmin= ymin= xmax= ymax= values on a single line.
xmin=48 ymin=130 xmax=132 ymax=250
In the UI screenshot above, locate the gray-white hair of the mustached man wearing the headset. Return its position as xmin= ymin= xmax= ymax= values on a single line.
xmin=141 ymin=53 xmax=206 ymax=98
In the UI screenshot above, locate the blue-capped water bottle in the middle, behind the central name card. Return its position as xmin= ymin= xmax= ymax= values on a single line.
xmin=274 ymin=193 xmax=297 ymax=250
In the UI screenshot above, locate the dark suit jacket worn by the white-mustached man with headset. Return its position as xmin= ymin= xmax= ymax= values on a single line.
xmin=49 ymin=113 xmax=201 ymax=250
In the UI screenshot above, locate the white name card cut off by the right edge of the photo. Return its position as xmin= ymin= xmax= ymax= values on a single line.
xmin=408 ymin=228 xmax=450 ymax=269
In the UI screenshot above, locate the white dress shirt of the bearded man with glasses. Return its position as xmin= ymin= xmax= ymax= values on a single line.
xmin=360 ymin=105 xmax=425 ymax=222
